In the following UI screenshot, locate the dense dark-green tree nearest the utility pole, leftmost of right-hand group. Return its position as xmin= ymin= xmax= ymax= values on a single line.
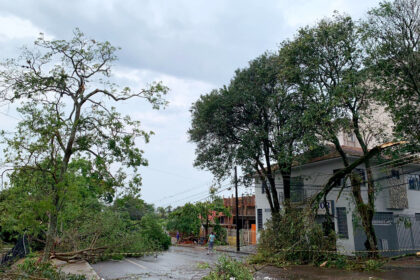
xmin=189 ymin=53 xmax=309 ymax=214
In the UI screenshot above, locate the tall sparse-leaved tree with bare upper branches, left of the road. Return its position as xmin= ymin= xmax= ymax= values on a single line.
xmin=0 ymin=29 xmax=167 ymax=260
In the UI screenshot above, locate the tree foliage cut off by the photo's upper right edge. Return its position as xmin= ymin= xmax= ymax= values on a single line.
xmin=362 ymin=0 xmax=420 ymax=147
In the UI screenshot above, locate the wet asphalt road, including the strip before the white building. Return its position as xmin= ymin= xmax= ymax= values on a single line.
xmin=92 ymin=246 xmax=420 ymax=280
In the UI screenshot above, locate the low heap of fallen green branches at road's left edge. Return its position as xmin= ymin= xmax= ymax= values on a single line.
xmin=57 ymin=207 xmax=171 ymax=260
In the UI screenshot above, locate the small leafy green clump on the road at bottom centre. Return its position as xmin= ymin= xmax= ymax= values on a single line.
xmin=202 ymin=256 xmax=253 ymax=280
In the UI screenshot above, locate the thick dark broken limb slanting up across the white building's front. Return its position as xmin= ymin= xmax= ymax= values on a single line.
xmin=310 ymin=141 xmax=408 ymax=211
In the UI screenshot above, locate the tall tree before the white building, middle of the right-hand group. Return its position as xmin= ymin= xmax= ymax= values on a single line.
xmin=283 ymin=14 xmax=390 ymax=254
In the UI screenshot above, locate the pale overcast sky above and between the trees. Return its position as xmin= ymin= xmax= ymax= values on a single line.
xmin=0 ymin=0 xmax=379 ymax=206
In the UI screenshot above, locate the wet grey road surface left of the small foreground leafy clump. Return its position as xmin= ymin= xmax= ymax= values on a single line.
xmin=92 ymin=246 xmax=238 ymax=279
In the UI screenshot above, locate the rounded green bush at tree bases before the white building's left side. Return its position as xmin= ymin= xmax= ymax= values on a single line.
xmin=251 ymin=208 xmax=336 ymax=266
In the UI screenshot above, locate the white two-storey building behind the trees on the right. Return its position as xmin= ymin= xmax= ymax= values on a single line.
xmin=255 ymin=135 xmax=420 ymax=255
